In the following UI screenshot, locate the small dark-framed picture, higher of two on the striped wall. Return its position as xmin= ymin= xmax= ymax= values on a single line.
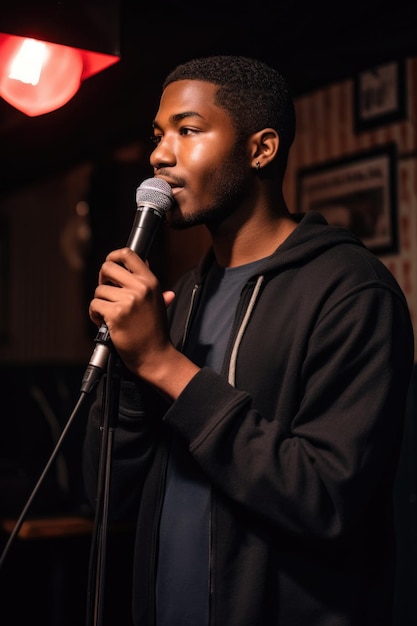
xmin=353 ymin=61 xmax=407 ymax=133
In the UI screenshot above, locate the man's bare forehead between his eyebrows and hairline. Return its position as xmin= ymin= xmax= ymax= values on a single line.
xmin=156 ymin=80 xmax=231 ymax=125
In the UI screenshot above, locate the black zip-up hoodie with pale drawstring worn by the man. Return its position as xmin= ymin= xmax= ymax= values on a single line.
xmin=85 ymin=213 xmax=414 ymax=626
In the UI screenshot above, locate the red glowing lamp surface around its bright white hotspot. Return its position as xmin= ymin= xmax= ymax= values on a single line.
xmin=0 ymin=34 xmax=119 ymax=117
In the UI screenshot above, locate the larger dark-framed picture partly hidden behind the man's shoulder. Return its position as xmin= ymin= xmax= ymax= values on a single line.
xmin=296 ymin=143 xmax=398 ymax=256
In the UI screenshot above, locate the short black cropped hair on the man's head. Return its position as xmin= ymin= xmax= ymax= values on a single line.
xmin=162 ymin=55 xmax=295 ymax=161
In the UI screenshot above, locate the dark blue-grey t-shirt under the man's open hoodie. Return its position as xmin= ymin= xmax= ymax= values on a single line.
xmin=156 ymin=261 xmax=261 ymax=626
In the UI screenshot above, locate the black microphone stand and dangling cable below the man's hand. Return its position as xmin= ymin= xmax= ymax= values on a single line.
xmin=0 ymin=336 xmax=121 ymax=626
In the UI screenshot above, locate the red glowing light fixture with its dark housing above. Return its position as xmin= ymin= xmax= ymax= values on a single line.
xmin=0 ymin=1 xmax=120 ymax=116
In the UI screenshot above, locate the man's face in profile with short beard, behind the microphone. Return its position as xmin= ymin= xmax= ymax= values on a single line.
xmin=150 ymin=80 xmax=251 ymax=228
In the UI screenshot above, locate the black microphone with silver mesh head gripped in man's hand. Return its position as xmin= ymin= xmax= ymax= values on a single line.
xmin=81 ymin=178 xmax=174 ymax=393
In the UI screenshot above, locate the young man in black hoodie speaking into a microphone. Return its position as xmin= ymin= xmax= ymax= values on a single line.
xmin=85 ymin=56 xmax=413 ymax=626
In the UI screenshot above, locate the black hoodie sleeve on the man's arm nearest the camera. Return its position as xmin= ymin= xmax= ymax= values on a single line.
xmin=164 ymin=270 xmax=413 ymax=538
